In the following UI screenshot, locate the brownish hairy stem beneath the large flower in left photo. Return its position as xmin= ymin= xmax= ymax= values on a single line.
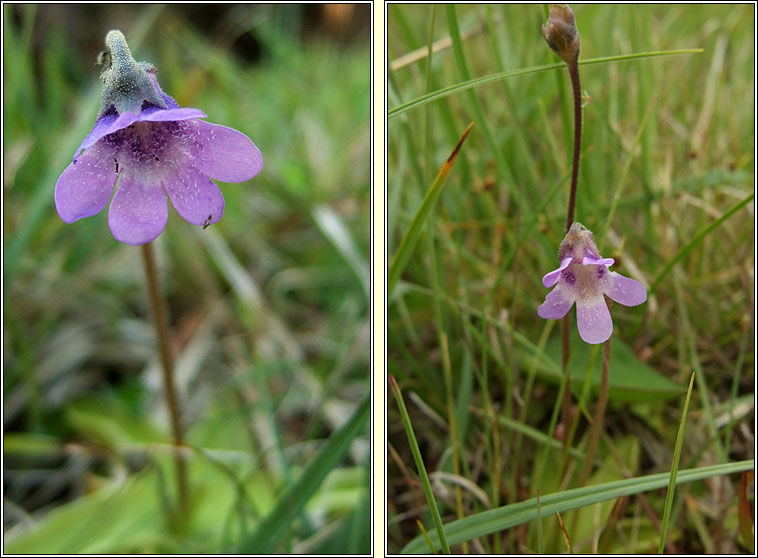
xmin=142 ymin=242 xmax=187 ymax=523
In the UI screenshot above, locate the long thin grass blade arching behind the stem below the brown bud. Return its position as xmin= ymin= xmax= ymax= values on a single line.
xmin=387 ymin=48 xmax=703 ymax=118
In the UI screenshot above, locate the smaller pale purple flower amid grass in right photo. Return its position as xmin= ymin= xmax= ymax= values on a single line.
xmin=537 ymin=223 xmax=647 ymax=344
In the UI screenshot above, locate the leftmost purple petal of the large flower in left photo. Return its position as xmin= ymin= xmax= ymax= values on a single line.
xmin=55 ymin=141 xmax=118 ymax=223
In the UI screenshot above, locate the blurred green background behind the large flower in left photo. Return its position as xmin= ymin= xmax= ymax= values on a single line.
xmin=3 ymin=4 xmax=371 ymax=553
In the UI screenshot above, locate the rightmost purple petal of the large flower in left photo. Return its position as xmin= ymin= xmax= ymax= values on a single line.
xmin=188 ymin=120 xmax=263 ymax=182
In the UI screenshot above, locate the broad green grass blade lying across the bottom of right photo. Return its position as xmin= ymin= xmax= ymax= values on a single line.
xmin=402 ymin=459 xmax=755 ymax=554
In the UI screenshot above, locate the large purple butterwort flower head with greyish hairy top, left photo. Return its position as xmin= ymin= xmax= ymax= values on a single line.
xmin=55 ymin=30 xmax=263 ymax=246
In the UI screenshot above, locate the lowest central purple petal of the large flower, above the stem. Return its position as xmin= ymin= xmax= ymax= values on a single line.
xmin=108 ymin=172 xmax=168 ymax=246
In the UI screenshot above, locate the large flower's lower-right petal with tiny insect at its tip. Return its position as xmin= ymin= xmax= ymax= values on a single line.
xmin=163 ymin=165 xmax=224 ymax=225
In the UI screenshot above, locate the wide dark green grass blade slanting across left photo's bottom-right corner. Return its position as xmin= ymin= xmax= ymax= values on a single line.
xmin=239 ymin=395 xmax=371 ymax=554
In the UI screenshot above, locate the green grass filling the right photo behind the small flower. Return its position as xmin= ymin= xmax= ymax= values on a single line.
xmin=387 ymin=4 xmax=755 ymax=553
